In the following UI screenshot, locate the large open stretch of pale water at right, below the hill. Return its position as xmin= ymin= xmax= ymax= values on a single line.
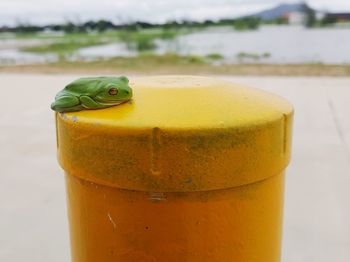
xmin=172 ymin=26 xmax=350 ymax=64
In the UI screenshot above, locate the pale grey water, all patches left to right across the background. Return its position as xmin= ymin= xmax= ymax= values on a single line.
xmin=0 ymin=26 xmax=350 ymax=64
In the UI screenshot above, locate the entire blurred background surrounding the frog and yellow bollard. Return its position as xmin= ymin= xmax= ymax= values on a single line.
xmin=0 ymin=0 xmax=350 ymax=262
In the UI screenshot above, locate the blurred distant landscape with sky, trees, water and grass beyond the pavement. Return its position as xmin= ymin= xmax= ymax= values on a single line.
xmin=0 ymin=0 xmax=350 ymax=75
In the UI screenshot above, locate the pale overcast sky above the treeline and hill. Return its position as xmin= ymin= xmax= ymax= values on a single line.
xmin=0 ymin=0 xmax=350 ymax=25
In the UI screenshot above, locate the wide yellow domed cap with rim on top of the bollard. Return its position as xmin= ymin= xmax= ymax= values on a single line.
xmin=56 ymin=76 xmax=293 ymax=192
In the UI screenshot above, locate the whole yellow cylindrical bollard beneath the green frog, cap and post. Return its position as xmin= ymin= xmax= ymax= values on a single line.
xmin=56 ymin=76 xmax=293 ymax=262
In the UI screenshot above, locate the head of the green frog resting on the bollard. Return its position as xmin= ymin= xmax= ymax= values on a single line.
xmin=94 ymin=76 xmax=132 ymax=105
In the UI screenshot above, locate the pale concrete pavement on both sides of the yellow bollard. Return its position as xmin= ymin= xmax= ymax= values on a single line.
xmin=0 ymin=74 xmax=350 ymax=262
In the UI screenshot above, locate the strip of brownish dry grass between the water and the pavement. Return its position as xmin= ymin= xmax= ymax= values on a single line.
xmin=0 ymin=61 xmax=350 ymax=77
